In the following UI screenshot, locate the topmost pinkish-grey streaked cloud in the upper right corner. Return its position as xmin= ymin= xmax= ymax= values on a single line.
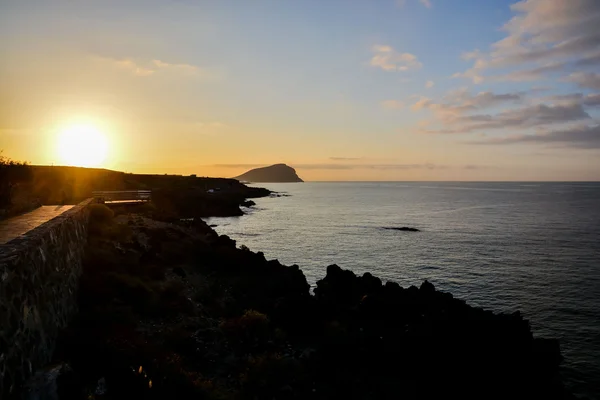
xmin=454 ymin=0 xmax=600 ymax=83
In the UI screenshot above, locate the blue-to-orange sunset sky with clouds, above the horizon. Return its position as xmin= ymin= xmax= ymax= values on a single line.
xmin=0 ymin=0 xmax=600 ymax=181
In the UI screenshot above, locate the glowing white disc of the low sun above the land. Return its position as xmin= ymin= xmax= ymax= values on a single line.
xmin=58 ymin=124 xmax=108 ymax=167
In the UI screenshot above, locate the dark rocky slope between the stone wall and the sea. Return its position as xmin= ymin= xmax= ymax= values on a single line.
xmin=30 ymin=188 xmax=570 ymax=399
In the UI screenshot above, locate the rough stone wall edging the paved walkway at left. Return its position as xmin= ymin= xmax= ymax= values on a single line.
xmin=0 ymin=200 xmax=91 ymax=398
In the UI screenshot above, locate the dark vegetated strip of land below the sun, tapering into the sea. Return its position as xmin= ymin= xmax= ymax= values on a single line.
xmin=0 ymin=157 xmax=270 ymax=218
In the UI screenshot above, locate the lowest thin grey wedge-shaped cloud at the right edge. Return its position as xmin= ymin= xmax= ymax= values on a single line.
xmin=471 ymin=125 xmax=600 ymax=149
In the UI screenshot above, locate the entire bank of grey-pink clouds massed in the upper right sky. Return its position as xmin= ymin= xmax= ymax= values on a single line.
xmin=420 ymin=0 xmax=600 ymax=148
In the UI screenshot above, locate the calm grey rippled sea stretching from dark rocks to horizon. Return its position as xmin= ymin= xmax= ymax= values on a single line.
xmin=208 ymin=182 xmax=600 ymax=399
